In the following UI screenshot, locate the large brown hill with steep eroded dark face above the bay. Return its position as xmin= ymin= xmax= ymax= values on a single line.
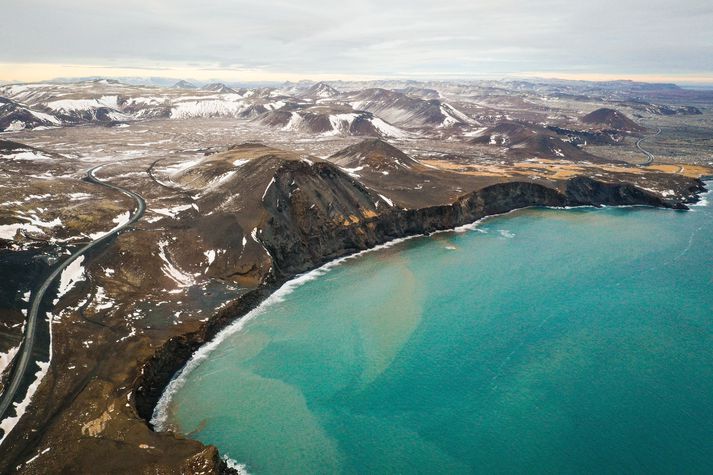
xmin=162 ymin=143 xmax=390 ymax=285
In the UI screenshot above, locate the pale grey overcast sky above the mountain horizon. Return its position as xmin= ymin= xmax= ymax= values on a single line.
xmin=0 ymin=0 xmax=713 ymax=82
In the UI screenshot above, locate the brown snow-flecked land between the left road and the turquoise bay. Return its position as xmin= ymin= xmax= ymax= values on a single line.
xmin=0 ymin=136 xmax=702 ymax=473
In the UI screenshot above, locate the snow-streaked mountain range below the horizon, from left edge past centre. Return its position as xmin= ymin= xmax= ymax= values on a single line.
xmin=0 ymin=80 xmax=478 ymax=138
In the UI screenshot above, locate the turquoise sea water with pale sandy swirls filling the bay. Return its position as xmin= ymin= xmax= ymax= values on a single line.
xmin=165 ymin=190 xmax=713 ymax=474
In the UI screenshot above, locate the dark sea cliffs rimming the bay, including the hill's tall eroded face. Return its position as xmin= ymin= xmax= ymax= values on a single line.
xmin=133 ymin=171 xmax=704 ymax=432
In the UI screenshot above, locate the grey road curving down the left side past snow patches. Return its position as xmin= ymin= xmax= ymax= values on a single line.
xmin=0 ymin=165 xmax=146 ymax=432
